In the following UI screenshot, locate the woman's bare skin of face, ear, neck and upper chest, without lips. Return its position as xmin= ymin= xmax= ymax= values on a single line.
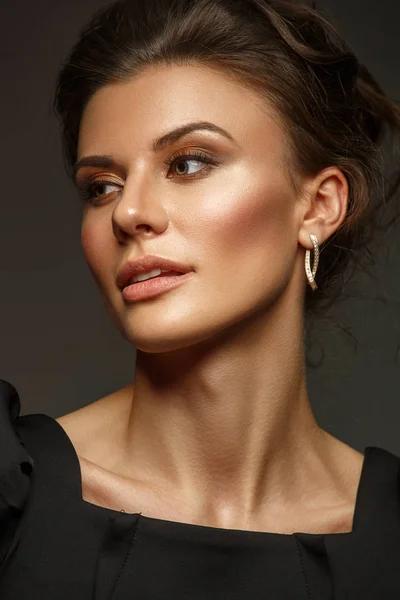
xmin=57 ymin=65 xmax=364 ymax=534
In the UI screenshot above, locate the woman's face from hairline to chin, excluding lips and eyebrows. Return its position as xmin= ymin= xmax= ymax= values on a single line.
xmin=77 ymin=66 xmax=305 ymax=352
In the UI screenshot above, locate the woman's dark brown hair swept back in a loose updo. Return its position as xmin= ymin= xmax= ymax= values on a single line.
xmin=54 ymin=0 xmax=400 ymax=356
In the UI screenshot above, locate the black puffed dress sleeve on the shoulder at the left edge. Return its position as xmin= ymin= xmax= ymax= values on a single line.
xmin=0 ymin=379 xmax=33 ymax=568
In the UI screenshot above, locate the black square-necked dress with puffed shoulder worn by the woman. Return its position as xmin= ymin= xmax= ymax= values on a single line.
xmin=0 ymin=380 xmax=400 ymax=600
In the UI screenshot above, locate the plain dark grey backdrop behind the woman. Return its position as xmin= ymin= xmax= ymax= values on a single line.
xmin=0 ymin=0 xmax=400 ymax=455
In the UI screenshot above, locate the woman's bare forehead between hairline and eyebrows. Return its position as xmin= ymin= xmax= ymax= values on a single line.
xmin=78 ymin=65 xmax=283 ymax=157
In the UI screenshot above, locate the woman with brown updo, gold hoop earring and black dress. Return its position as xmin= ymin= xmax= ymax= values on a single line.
xmin=0 ymin=0 xmax=400 ymax=600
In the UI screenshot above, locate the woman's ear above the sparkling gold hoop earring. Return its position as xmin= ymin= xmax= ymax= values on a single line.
xmin=299 ymin=167 xmax=349 ymax=249
